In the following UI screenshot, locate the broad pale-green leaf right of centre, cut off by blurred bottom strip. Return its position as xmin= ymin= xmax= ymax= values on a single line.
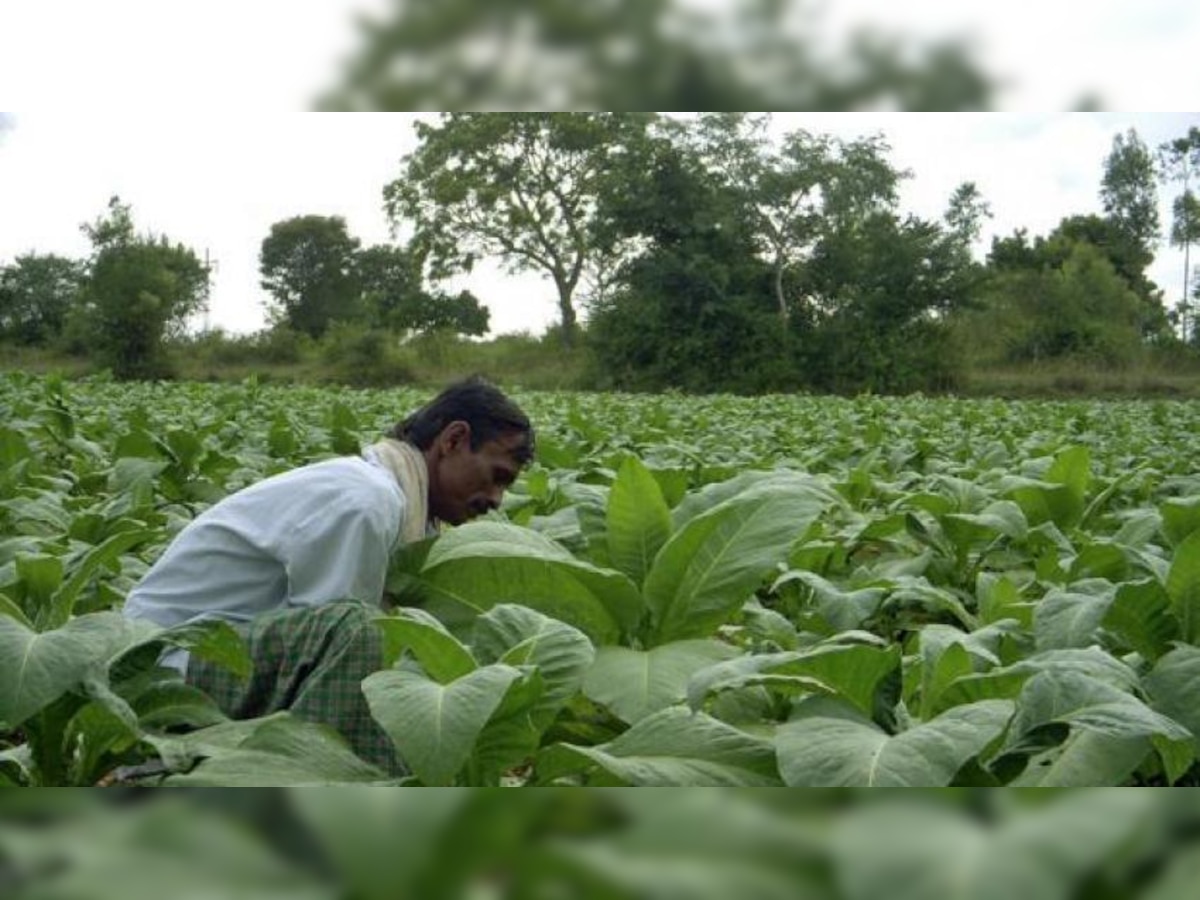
xmin=775 ymin=700 xmax=1013 ymax=787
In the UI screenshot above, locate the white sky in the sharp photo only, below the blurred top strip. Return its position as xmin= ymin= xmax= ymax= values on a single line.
xmin=0 ymin=110 xmax=1200 ymax=334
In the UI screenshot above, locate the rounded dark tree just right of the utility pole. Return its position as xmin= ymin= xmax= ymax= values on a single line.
xmin=258 ymin=216 xmax=360 ymax=337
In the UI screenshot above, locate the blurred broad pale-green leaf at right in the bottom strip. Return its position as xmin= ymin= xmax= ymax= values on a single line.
xmin=832 ymin=791 xmax=1162 ymax=900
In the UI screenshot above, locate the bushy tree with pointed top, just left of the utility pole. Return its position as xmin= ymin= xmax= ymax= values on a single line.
xmin=80 ymin=197 xmax=209 ymax=378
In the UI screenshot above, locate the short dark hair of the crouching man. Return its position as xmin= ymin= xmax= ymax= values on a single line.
xmin=388 ymin=376 xmax=534 ymax=464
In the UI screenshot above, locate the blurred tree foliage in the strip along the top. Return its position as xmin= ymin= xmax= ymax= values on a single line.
xmin=318 ymin=0 xmax=994 ymax=110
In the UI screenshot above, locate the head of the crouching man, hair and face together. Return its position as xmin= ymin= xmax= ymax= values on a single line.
xmin=390 ymin=378 xmax=534 ymax=524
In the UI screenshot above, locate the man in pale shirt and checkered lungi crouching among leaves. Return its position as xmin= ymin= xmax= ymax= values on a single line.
xmin=125 ymin=379 xmax=534 ymax=772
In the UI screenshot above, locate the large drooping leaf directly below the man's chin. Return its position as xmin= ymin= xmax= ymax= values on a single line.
xmin=420 ymin=522 xmax=642 ymax=644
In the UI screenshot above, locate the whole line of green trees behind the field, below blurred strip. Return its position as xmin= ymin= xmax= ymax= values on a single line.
xmin=0 ymin=113 xmax=1200 ymax=392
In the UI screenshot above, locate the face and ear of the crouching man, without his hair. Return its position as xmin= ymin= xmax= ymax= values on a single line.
xmin=430 ymin=421 xmax=526 ymax=524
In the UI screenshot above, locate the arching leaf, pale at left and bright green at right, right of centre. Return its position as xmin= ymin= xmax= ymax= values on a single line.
xmin=688 ymin=644 xmax=900 ymax=716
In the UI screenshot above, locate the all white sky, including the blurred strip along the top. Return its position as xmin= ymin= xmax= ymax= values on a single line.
xmin=0 ymin=0 xmax=1200 ymax=332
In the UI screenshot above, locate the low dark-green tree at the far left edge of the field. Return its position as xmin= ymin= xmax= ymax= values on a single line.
xmin=0 ymin=253 xmax=85 ymax=346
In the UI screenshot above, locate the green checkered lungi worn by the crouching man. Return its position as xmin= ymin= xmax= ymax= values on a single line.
xmin=187 ymin=600 xmax=407 ymax=775
